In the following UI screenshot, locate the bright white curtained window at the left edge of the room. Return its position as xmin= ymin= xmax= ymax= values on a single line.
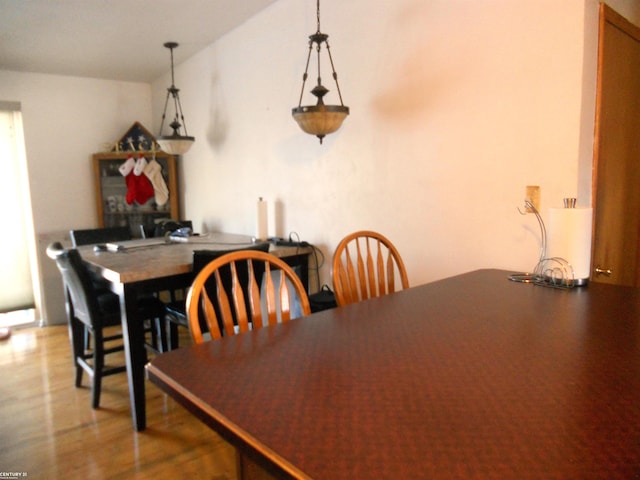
xmin=0 ymin=106 xmax=34 ymax=312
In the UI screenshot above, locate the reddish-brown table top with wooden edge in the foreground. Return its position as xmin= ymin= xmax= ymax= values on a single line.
xmin=147 ymin=270 xmax=640 ymax=479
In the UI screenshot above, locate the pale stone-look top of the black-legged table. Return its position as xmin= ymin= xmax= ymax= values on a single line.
xmin=78 ymin=233 xmax=311 ymax=283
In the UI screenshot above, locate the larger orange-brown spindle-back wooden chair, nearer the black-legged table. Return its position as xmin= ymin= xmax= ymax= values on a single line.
xmin=187 ymin=250 xmax=311 ymax=343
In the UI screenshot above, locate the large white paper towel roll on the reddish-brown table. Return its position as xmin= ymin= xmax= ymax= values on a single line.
xmin=547 ymin=208 xmax=593 ymax=280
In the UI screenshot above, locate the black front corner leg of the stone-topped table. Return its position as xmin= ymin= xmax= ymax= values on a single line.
xmin=117 ymin=284 xmax=147 ymax=432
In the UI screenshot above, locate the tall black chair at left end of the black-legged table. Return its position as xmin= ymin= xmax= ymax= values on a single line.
xmin=47 ymin=242 xmax=165 ymax=408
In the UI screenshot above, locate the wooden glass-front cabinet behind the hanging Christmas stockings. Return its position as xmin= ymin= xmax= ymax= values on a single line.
xmin=93 ymin=152 xmax=180 ymax=238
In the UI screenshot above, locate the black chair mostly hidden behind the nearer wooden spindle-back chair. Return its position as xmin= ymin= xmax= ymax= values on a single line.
xmin=166 ymin=242 xmax=270 ymax=350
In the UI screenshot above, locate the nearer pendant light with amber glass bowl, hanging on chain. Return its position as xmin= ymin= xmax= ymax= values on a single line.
xmin=291 ymin=0 xmax=349 ymax=143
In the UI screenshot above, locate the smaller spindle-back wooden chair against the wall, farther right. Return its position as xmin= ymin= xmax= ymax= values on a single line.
xmin=332 ymin=230 xmax=409 ymax=306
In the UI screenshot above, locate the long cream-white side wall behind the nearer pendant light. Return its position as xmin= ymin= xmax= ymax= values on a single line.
xmin=153 ymin=0 xmax=597 ymax=284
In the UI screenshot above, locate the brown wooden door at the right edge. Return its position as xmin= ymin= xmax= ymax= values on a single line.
xmin=591 ymin=4 xmax=640 ymax=286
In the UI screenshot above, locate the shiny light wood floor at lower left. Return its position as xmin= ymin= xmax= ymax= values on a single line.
xmin=0 ymin=326 xmax=236 ymax=480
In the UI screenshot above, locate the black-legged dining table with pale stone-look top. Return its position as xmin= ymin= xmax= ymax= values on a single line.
xmin=78 ymin=233 xmax=313 ymax=431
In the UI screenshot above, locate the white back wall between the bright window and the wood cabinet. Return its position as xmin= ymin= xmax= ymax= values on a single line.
xmin=0 ymin=71 xmax=151 ymax=323
